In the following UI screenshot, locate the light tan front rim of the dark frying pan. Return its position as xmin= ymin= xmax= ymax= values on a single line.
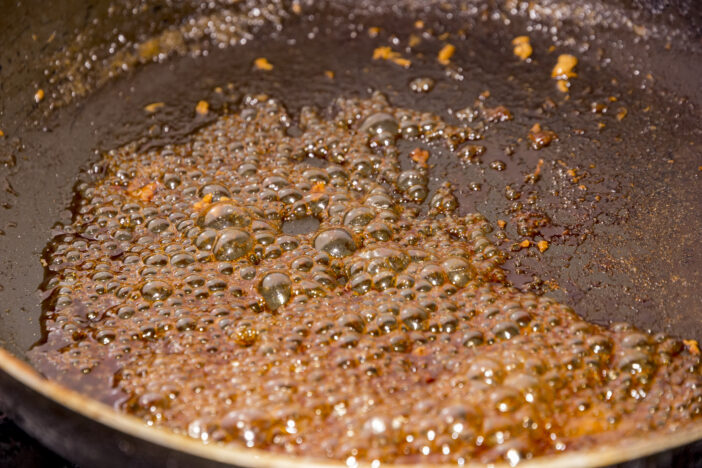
xmin=0 ymin=347 xmax=702 ymax=468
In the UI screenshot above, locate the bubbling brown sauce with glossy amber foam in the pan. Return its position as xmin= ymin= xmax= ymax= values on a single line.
xmin=33 ymin=94 xmax=702 ymax=464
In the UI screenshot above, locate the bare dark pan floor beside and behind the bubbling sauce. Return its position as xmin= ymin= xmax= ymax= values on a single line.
xmin=1 ymin=0 xmax=702 ymax=464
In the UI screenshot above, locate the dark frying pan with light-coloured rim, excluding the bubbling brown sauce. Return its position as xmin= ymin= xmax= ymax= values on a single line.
xmin=0 ymin=0 xmax=702 ymax=467
